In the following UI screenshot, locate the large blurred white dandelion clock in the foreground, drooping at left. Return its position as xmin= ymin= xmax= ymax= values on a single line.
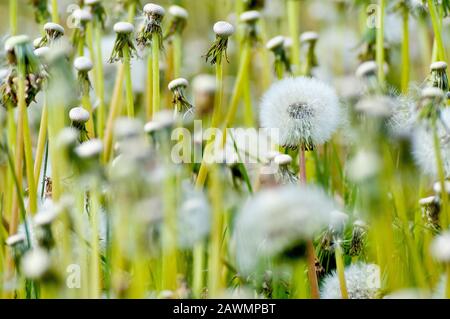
xmin=234 ymin=185 xmax=335 ymax=273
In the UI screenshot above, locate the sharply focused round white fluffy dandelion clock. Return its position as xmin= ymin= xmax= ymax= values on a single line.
xmin=260 ymin=77 xmax=342 ymax=150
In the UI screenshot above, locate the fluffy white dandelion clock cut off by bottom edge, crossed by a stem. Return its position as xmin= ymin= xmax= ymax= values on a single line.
xmin=320 ymin=263 xmax=381 ymax=299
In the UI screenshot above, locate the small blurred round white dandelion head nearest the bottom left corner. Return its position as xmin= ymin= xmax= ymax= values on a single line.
xmin=21 ymin=247 xmax=51 ymax=279
